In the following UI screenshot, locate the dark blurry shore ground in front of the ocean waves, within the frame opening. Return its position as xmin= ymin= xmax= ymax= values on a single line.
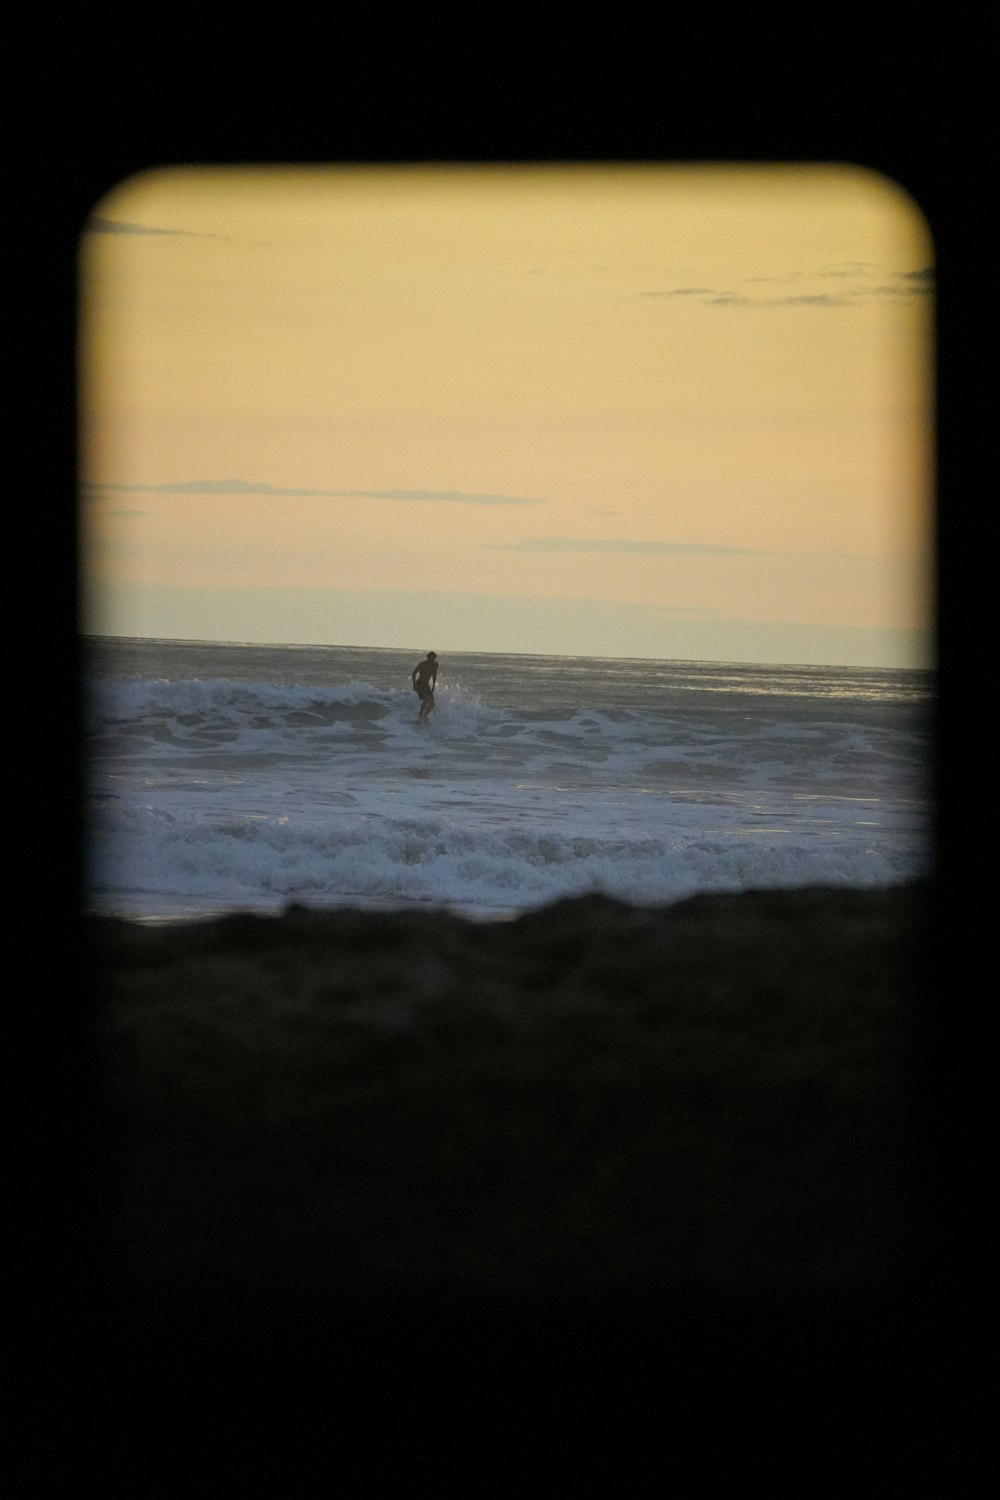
xmin=84 ymin=885 xmax=936 ymax=1362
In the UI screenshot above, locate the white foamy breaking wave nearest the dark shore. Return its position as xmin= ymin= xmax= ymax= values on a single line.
xmin=88 ymin=803 xmax=921 ymax=912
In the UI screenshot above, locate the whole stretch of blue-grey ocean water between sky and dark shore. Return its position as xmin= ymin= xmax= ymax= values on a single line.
xmin=84 ymin=638 xmax=934 ymax=918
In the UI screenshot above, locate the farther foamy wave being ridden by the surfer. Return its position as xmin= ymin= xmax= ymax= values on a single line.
xmin=85 ymin=678 xmax=925 ymax=801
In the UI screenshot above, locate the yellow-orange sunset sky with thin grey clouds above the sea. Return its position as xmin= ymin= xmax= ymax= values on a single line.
xmin=78 ymin=164 xmax=934 ymax=668
